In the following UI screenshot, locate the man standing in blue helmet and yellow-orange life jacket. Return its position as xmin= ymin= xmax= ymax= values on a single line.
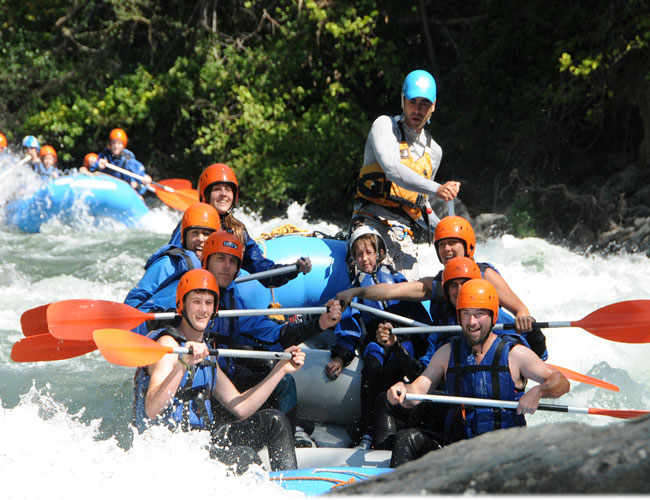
xmin=351 ymin=70 xmax=460 ymax=280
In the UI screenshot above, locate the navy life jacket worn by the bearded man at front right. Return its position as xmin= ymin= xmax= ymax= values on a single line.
xmin=445 ymin=336 xmax=526 ymax=438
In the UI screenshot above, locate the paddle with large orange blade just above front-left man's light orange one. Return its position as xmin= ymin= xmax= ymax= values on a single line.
xmin=21 ymin=299 xmax=327 ymax=341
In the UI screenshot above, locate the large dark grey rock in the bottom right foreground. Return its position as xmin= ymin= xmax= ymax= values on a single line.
xmin=332 ymin=417 xmax=650 ymax=495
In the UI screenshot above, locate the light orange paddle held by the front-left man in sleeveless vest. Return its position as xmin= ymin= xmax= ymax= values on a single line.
xmin=93 ymin=328 xmax=291 ymax=367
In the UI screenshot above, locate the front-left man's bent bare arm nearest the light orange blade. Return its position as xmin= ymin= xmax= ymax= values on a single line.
xmin=144 ymin=335 xmax=208 ymax=418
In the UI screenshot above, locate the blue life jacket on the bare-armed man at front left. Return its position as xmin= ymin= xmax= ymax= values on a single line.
xmin=133 ymin=327 xmax=217 ymax=432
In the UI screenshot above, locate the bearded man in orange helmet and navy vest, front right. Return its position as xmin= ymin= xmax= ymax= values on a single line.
xmin=386 ymin=279 xmax=570 ymax=467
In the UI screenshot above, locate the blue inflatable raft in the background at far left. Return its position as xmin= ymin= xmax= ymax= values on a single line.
xmin=5 ymin=174 xmax=149 ymax=233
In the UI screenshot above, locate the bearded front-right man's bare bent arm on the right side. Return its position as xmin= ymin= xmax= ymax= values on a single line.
xmin=508 ymin=345 xmax=570 ymax=414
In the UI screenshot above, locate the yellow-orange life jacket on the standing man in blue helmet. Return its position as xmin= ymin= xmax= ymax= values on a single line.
xmin=355 ymin=121 xmax=433 ymax=221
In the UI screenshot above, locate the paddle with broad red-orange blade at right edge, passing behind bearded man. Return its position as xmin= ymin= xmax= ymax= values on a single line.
xmin=393 ymin=299 xmax=650 ymax=344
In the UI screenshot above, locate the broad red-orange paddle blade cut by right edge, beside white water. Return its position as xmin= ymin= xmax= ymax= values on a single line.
xmin=571 ymin=300 xmax=650 ymax=344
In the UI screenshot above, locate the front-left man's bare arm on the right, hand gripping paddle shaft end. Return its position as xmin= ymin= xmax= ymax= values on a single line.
xmin=213 ymin=346 xmax=305 ymax=419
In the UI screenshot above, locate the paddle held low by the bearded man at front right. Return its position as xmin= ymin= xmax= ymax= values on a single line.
xmin=406 ymin=394 xmax=650 ymax=418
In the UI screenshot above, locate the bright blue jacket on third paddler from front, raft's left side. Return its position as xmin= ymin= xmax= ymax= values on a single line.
xmin=124 ymin=245 xmax=201 ymax=312
